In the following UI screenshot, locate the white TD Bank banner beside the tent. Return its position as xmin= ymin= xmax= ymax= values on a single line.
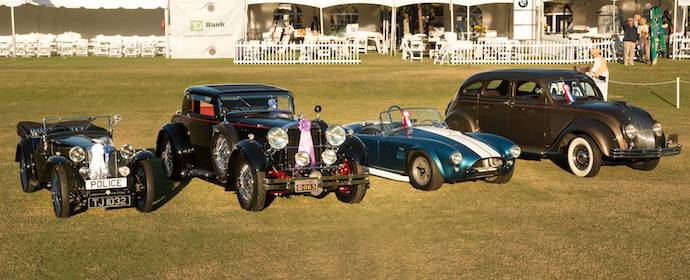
xmin=170 ymin=0 xmax=245 ymax=58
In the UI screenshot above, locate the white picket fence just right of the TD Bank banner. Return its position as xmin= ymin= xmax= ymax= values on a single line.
xmin=235 ymin=41 xmax=362 ymax=65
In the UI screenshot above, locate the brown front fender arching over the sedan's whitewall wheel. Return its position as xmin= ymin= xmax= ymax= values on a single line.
xmin=547 ymin=119 xmax=618 ymax=157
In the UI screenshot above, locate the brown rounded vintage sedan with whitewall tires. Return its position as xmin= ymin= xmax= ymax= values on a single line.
xmin=446 ymin=69 xmax=681 ymax=177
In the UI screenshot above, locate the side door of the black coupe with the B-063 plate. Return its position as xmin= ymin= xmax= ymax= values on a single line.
xmin=187 ymin=95 xmax=218 ymax=170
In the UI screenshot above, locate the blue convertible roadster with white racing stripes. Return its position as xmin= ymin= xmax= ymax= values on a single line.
xmin=346 ymin=106 xmax=520 ymax=191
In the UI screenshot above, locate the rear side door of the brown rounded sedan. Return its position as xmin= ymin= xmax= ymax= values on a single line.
xmin=477 ymin=79 xmax=512 ymax=138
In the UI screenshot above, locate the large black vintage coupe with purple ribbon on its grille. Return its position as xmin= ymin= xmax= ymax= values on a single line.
xmin=156 ymin=84 xmax=369 ymax=211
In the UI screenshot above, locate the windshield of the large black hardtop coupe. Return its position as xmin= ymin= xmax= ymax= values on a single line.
xmin=220 ymin=94 xmax=294 ymax=114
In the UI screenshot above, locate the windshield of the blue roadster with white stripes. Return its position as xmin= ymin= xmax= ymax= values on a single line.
xmin=379 ymin=108 xmax=444 ymax=130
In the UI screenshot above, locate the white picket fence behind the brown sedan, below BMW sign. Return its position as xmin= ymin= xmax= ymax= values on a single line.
xmin=434 ymin=40 xmax=616 ymax=64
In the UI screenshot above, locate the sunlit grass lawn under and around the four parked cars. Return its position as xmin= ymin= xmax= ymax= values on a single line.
xmin=0 ymin=55 xmax=690 ymax=279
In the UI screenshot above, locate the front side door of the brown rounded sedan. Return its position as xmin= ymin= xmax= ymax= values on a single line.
xmin=510 ymin=80 xmax=546 ymax=153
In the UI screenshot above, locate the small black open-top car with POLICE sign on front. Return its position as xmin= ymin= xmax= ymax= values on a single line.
xmin=15 ymin=115 xmax=155 ymax=218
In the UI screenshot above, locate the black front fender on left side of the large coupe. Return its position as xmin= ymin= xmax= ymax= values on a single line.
xmin=226 ymin=139 xmax=270 ymax=190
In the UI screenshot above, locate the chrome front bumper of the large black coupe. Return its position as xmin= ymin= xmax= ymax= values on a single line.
xmin=264 ymin=174 xmax=369 ymax=191
